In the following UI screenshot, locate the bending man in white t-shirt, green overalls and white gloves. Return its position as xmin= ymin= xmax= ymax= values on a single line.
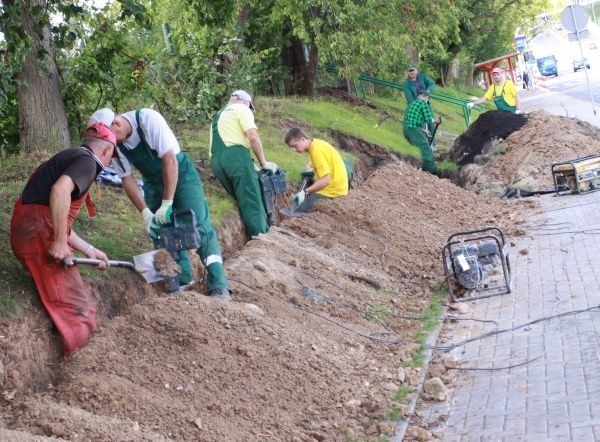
xmin=92 ymin=109 xmax=231 ymax=301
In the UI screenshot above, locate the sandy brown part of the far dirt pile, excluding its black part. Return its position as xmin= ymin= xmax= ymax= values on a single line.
xmin=460 ymin=111 xmax=600 ymax=196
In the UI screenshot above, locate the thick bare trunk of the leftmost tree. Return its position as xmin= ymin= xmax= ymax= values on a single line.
xmin=15 ymin=0 xmax=71 ymax=152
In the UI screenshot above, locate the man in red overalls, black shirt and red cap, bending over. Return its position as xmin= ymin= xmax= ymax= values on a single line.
xmin=10 ymin=123 xmax=117 ymax=356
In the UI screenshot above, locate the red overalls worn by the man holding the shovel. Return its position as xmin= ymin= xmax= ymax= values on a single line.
xmin=10 ymin=195 xmax=96 ymax=356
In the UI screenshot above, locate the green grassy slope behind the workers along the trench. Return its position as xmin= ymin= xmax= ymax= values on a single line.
xmin=0 ymin=84 xmax=492 ymax=316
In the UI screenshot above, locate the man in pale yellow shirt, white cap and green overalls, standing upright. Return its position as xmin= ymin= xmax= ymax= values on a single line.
xmin=210 ymin=90 xmax=278 ymax=238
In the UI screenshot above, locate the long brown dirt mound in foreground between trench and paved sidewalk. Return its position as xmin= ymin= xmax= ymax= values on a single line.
xmin=0 ymin=162 xmax=532 ymax=441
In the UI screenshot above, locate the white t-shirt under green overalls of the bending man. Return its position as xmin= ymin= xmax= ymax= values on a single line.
xmin=112 ymin=109 xmax=181 ymax=178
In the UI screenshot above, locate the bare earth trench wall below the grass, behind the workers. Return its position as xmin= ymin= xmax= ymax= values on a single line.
xmin=0 ymin=133 xmax=394 ymax=401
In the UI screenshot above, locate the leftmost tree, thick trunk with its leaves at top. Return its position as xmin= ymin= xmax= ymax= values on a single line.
xmin=0 ymin=0 xmax=149 ymax=152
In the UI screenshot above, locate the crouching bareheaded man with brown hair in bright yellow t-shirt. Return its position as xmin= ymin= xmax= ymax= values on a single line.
xmin=284 ymin=127 xmax=349 ymax=214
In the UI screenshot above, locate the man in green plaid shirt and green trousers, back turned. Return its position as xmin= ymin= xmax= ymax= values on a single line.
xmin=403 ymin=91 xmax=441 ymax=174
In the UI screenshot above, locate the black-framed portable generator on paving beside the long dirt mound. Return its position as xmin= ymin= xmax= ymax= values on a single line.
xmin=442 ymin=227 xmax=510 ymax=302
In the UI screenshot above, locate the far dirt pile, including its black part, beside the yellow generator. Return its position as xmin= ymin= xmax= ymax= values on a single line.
xmin=451 ymin=111 xmax=600 ymax=196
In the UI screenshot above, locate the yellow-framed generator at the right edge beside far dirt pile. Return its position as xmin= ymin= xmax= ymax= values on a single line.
xmin=552 ymin=155 xmax=600 ymax=195
